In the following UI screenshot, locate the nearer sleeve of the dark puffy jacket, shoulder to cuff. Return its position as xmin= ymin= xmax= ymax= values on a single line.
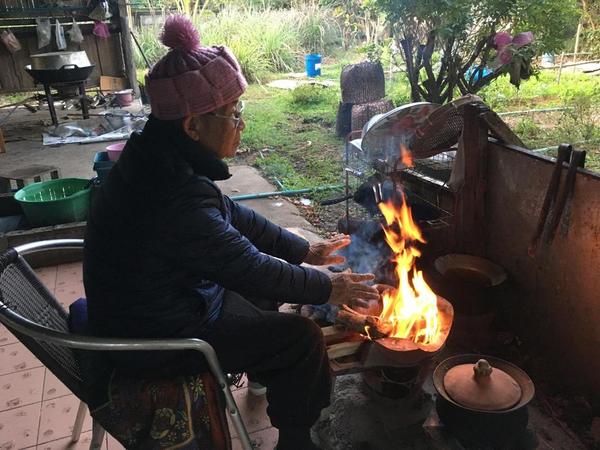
xmin=166 ymin=202 xmax=331 ymax=304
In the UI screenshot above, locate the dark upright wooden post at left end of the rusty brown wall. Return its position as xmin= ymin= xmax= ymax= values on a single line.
xmin=454 ymin=104 xmax=488 ymax=256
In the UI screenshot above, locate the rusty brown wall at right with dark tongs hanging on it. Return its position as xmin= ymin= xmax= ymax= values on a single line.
xmin=485 ymin=143 xmax=600 ymax=395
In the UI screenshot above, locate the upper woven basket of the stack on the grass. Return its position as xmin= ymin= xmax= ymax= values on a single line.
xmin=340 ymin=61 xmax=385 ymax=103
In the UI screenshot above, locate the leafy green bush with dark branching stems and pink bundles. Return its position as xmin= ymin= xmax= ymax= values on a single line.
xmin=373 ymin=0 xmax=578 ymax=103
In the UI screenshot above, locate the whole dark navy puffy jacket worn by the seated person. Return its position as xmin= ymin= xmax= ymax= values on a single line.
xmin=83 ymin=117 xmax=331 ymax=372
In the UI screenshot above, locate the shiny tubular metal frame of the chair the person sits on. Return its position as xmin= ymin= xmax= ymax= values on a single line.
xmin=0 ymin=243 xmax=252 ymax=450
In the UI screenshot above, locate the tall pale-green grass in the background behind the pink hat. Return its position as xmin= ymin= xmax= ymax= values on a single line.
xmin=135 ymin=6 xmax=341 ymax=82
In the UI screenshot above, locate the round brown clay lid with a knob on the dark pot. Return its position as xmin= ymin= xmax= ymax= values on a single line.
xmin=444 ymin=359 xmax=522 ymax=411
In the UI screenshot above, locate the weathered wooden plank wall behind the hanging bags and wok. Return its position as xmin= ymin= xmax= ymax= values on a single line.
xmin=0 ymin=0 xmax=126 ymax=93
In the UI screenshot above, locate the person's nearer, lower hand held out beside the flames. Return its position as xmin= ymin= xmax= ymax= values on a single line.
xmin=328 ymin=272 xmax=379 ymax=308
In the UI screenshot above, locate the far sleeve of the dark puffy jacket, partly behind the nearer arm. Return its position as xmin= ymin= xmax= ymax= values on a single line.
xmin=224 ymin=196 xmax=309 ymax=264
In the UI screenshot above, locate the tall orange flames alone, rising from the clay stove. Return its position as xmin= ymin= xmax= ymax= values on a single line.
xmin=379 ymin=197 xmax=441 ymax=344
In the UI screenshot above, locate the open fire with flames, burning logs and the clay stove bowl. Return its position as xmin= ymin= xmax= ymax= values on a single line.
xmin=332 ymin=191 xmax=454 ymax=358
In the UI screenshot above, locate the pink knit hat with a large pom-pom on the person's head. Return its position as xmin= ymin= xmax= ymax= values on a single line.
xmin=146 ymin=15 xmax=248 ymax=120
